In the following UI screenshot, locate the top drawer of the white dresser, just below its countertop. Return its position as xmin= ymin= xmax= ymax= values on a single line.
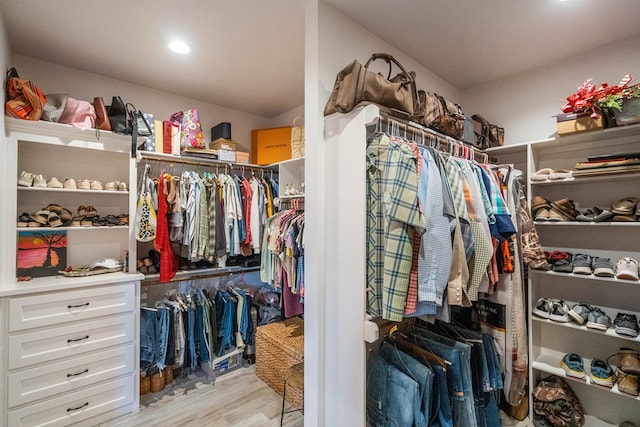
xmin=9 ymin=283 xmax=135 ymax=332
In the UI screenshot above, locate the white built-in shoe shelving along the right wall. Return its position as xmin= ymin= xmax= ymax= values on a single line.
xmin=487 ymin=125 xmax=640 ymax=425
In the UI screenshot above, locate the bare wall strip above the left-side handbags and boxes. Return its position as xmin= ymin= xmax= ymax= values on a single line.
xmin=12 ymin=55 xmax=278 ymax=151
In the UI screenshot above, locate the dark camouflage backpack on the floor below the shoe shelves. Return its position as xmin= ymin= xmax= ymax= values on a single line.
xmin=533 ymin=376 xmax=584 ymax=427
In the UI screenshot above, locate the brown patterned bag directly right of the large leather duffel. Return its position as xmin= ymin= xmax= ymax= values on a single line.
xmin=418 ymin=90 xmax=464 ymax=140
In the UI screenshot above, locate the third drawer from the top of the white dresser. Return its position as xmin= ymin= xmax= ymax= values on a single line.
xmin=8 ymin=343 xmax=134 ymax=408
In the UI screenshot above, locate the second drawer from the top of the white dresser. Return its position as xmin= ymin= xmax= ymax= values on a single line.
xmin=9 ymin=313 xmax=135 ymax=369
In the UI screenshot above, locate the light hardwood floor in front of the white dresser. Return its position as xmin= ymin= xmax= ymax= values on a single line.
xmin=100 ymin=365 xmax=304 ymax=427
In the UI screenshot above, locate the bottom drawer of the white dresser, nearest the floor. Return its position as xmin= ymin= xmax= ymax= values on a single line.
xmin=8 ymin=378 xmax=134 ymax=427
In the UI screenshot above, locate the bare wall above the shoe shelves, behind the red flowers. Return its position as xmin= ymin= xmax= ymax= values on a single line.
xmin=462 ymin=33 xmax=640 ymax=144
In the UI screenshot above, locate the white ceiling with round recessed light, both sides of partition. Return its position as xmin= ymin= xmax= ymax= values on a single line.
xmin=0 ymin=0 xmax=640 ymax=117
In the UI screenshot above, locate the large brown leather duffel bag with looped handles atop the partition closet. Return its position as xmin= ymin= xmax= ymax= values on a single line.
xmin=324 ymin=53 xmax=419 ymax=117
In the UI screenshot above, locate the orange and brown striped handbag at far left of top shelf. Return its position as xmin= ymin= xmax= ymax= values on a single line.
xmin=5 ymin=67 xmax=47 ymax=120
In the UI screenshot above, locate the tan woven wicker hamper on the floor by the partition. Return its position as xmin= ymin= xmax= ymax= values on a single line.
xmin=256 ymin=317 xmax=304 ymax=408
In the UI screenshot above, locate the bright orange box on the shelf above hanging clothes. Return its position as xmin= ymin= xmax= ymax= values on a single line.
xmin=251 ymin=126 xmax=291 ymax=165
